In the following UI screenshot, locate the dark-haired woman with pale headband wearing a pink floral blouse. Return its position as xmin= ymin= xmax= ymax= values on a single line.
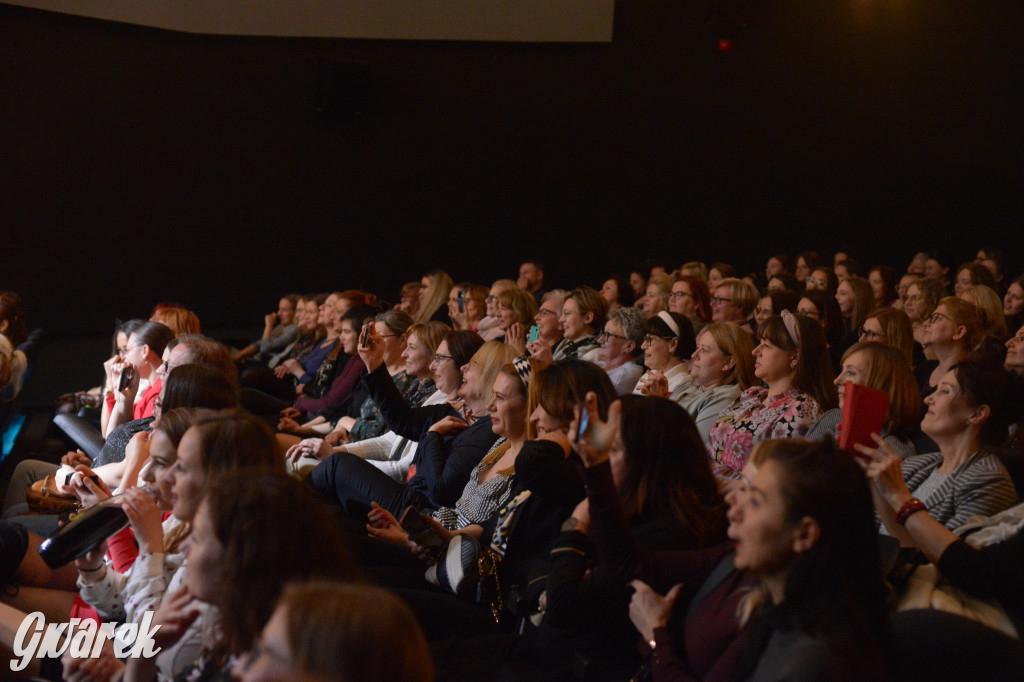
xmin=708 ymin=310 xmax=838 ymax=480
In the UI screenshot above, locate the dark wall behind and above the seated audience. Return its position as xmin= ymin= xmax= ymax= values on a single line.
xmin=0 ymin=0 xmax=1024 ymax=334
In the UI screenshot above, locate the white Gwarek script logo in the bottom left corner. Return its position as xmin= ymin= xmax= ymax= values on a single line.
xmin=10 ymin=611 xmax=162 ymax=673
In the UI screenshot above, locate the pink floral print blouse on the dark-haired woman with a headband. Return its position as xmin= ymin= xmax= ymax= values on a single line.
xmin=708 ymin=386 xmax=821 ymax=479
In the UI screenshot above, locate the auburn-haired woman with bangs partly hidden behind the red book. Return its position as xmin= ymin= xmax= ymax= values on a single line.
xmin=807 ymin=339 xmax=921 ymax=459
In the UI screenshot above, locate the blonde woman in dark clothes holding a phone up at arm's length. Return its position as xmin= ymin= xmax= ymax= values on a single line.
xmin=309 ymin=329 xmax=516 ymax=522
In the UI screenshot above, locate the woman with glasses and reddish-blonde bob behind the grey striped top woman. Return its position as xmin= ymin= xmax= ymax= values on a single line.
xmin=918 ymin=296 xmax=982 ymax=398
